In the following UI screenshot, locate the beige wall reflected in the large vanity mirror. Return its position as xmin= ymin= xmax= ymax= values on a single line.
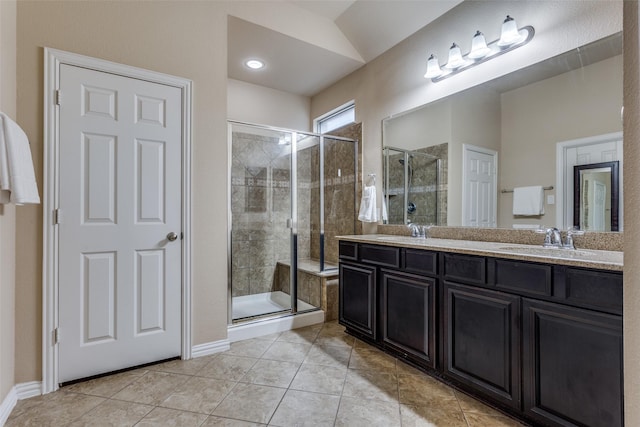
xmin=382 ymin=33 xmax=622 ymax=234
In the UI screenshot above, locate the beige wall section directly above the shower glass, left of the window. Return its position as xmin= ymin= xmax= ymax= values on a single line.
xmin=227 ymin=79 xmax=312 ymax=132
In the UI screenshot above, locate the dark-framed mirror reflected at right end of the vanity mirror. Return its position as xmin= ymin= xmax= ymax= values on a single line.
xmin=573 ymin=161 xmax=619 ymax=231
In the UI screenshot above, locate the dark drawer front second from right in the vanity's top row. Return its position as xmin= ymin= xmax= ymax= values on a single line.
xmin=495 ymin=259 xmax=552 ymax=296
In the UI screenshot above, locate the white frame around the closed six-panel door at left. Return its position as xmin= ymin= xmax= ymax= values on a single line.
xmin=42 ymin=48 xmax=192 ymax=393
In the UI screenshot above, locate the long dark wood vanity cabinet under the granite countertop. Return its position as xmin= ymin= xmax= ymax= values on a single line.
xmin=339 ymin=241 xmax=624 ymax=427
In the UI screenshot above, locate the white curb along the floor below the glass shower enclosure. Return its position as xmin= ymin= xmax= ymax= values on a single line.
xmin=227 ymin=310 xmax=324 ymax=342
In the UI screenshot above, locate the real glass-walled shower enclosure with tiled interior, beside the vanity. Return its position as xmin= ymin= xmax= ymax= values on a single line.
xmin=229 ymin=121 xmax=358 ymax=324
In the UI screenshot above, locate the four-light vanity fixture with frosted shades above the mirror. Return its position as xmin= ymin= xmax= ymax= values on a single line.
xmin=424 ymin=15 xmax=535 ymax=82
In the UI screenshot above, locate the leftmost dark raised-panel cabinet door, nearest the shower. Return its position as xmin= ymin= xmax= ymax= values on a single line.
xmin=339 ymin=262 xmax=377 ymax=339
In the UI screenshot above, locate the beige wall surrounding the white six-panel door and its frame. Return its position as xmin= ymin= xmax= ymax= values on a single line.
xmin=16 ymin=1 xmax=227 ymax=383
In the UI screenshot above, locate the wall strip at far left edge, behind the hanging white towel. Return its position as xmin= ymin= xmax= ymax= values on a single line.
xmin=0 ymin=0 xmax=16 ymax=403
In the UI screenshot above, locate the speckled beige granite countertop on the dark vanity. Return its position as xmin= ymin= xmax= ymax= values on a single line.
xmin=337 ymin=234 xmax=623 ymax=271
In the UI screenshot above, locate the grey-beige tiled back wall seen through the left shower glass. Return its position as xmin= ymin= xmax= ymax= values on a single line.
xmin=231 ymin=132 xmax=308 ymax=296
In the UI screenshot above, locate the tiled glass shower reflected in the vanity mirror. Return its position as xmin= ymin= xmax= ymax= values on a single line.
xmin=383 ymin=147 xmax=446 ymax=225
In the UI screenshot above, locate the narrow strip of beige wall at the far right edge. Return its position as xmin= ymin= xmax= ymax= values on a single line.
xmin=623 ymin=1 xmax=640 ymax=426
